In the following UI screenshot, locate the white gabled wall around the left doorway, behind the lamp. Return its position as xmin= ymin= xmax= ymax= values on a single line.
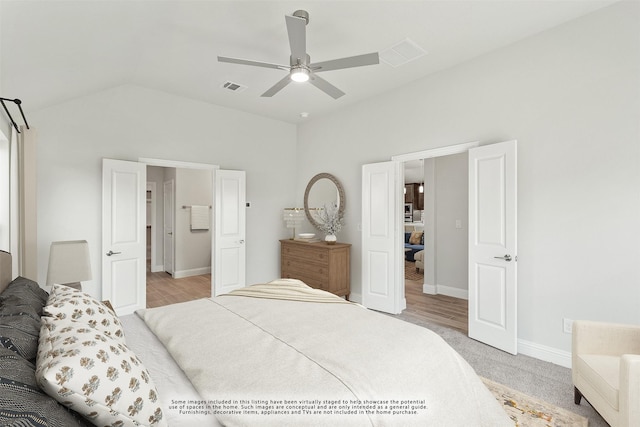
xmin=29 ymin=85 xmax=296 ymax=297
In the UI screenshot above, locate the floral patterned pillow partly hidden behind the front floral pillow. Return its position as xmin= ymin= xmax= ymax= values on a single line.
xmin=42 ymin=285 xmax=125 ymax=344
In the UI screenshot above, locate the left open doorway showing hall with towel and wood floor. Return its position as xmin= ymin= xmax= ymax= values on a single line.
xmin=146 ymin=166 xmax=213 ymax=308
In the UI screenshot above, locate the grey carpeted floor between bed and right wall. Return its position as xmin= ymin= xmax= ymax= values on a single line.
xmin=390 ymin=314 xmax=608 ymax=427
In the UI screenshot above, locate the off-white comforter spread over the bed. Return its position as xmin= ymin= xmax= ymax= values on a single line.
xmin=140 ymin=282 xmax=513 ymax=427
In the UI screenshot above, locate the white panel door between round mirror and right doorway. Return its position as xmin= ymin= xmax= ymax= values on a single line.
xmin=362 ymin=161 xmax=406 ymax=314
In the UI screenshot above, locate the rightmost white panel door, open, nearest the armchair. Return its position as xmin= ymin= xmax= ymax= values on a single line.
xmin=469 ymin=141 xmax=518 ymax=354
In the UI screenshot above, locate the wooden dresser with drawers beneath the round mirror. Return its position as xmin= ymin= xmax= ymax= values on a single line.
xmin=280 ymin=240 xmax=351 ymax=299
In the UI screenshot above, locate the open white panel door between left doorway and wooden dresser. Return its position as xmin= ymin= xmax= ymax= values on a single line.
xmin=211 ymin=169 xmax=246 ymax=296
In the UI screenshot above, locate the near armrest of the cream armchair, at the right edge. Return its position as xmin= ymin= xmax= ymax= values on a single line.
xmin=619 ymin=354 xmax=640 ymax=427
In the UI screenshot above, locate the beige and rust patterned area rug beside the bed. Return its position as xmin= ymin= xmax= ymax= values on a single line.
xmin=482 ymin=378 xmax=589 ymax=427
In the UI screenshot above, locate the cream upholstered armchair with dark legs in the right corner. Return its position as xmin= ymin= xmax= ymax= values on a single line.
xmin=571 ymin=320 xmax=640 ymax=427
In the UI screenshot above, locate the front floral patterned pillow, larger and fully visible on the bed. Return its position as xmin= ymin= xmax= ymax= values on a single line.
xmin=36 ymin=317 xmax=167 ymax=427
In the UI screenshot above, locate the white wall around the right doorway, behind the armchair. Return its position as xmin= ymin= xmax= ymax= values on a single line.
xmin=297 ymin=2 xmax=640 ymax=351
